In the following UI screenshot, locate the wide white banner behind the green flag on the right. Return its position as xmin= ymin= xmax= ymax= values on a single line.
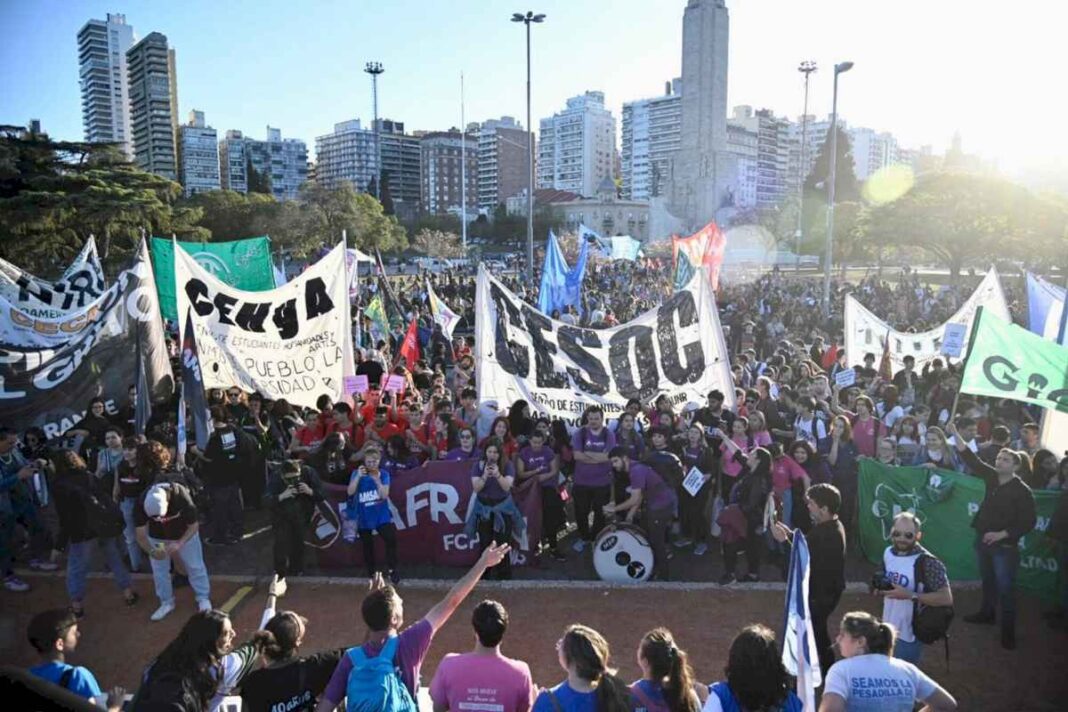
xmin=845 ymin=267 xmax=1012 ymax=373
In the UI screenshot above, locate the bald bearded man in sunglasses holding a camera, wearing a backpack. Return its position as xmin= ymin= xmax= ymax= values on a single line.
xmin=871 ymin=511 xmax=953 ymax=665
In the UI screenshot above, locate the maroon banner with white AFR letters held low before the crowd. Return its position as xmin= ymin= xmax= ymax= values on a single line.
xmin=318 ymin=460 xmax=541 ymax=568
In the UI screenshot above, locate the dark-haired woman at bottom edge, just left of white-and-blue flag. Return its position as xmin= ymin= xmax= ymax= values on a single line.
xmin=704 ymin=624 xmax=802 ymax=712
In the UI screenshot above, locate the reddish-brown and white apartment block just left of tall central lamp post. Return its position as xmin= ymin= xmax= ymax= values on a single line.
xmin=478 ymin=116 xmax=530 ymax=212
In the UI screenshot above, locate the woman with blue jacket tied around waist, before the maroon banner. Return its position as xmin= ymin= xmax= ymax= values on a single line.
xmin=465 ymin=439 xmax=525 ymax=581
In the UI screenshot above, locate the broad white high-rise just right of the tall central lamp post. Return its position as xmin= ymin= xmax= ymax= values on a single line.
xmin=535 ymin=92 xmax=615 ymax=196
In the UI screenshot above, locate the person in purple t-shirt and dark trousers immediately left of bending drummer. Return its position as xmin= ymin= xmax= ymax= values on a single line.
xmin=571 ymin=406 xmax=615 ymax=553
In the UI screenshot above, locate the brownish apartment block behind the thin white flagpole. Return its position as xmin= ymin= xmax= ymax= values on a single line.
xmin=420 ymin=129 xmax=478 ymax=217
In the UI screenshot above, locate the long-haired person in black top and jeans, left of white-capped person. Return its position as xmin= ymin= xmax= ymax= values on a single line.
xmin=50 ymin=449 xmax=138 ymax=618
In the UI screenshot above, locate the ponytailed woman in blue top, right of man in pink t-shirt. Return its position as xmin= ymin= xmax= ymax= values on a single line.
xmin=531 ymin=624 xmax=632 ymax=712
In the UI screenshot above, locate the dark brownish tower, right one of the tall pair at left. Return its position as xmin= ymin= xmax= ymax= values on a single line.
xmin=126 ymin=32 xmax=178 ymax=180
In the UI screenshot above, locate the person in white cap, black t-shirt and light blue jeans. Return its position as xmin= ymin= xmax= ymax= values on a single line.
xmin=135 ymin=481 xmax=211 ymax=620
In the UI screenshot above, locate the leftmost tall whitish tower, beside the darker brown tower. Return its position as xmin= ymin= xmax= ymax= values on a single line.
xmin=78 ymin=13 xmax=134 ymax=158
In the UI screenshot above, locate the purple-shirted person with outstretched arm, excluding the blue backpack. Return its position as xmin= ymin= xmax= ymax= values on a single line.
xmin=315 ymin=544 xmax=508 ymax=712
